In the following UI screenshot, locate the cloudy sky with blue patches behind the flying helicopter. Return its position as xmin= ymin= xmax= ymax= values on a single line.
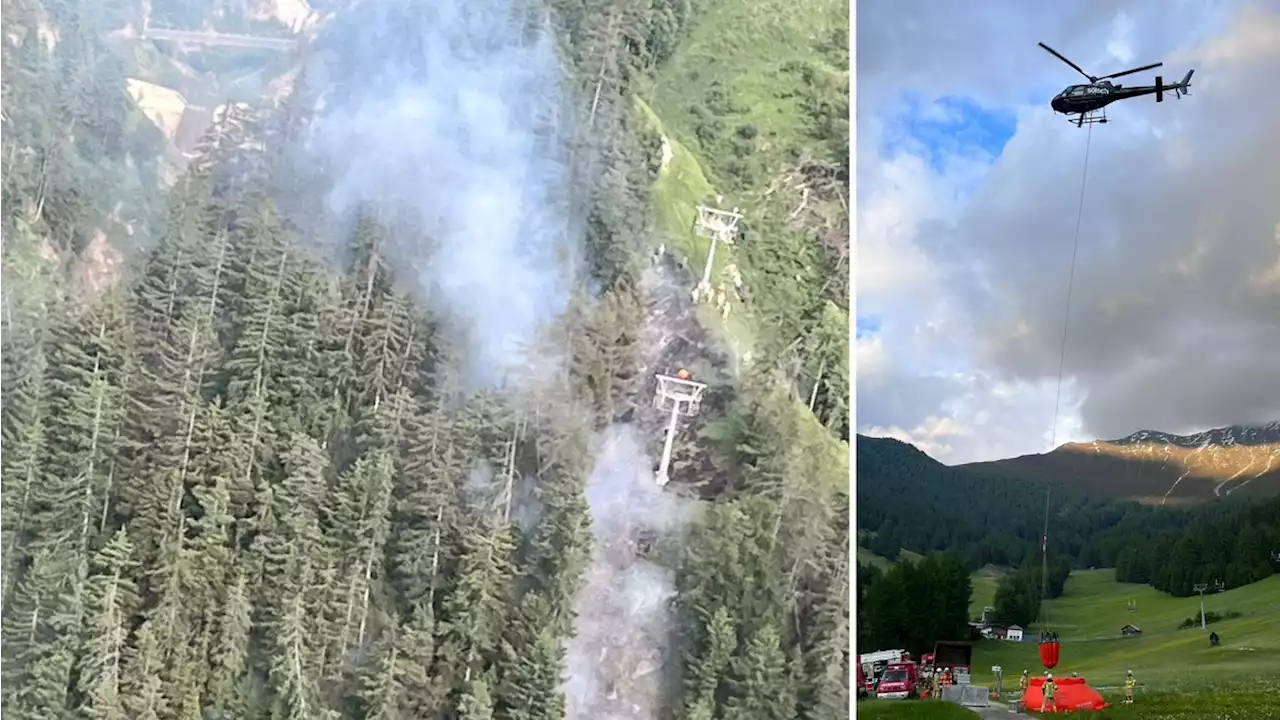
xmin=855 ymin=0 xmax=1280 ymax=462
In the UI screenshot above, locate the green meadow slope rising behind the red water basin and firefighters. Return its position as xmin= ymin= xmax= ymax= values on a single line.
xmin=974 ymin=570 xmax=1280 ymax=696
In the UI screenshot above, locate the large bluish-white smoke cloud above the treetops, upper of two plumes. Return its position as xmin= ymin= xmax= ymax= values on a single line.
xmin=310 ymin=0 xmax=581 ymax=382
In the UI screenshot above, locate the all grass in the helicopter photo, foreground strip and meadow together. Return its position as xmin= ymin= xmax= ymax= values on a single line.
xmin=858 ymin=563 xmax=1280 ymax=720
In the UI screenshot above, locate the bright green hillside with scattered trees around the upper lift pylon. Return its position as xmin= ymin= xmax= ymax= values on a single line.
xmin=640 ymin=0 xmax=850 ymax=439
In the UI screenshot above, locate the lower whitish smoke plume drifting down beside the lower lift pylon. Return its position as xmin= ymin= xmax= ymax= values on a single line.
xmin=564 ymin=424 xmax=695 ymax=720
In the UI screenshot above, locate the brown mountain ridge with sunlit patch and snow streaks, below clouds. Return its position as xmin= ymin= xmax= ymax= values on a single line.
xmin=957 ymin=423 xmax=1280 ymax=505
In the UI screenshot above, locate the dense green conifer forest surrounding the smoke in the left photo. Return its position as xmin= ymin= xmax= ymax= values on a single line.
xmin=0 ymin=0 xmax=851 ymax=720
